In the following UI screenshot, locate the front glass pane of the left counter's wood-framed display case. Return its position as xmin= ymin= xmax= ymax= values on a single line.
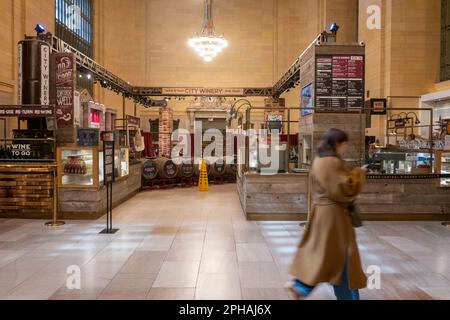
xmin=61 ymin=150 xmax=94 ymax=186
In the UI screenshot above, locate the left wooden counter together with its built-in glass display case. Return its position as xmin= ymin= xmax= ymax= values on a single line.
xmin=58 ymin=146 xmax=142 ymax=219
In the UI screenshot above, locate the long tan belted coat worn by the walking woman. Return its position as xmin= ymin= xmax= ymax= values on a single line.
xmin=290 ymin=157 xmax=367 ymax=290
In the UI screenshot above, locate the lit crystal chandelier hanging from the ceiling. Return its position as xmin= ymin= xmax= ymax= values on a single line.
xmin=189 ymin=0 xmax=228 ymax=62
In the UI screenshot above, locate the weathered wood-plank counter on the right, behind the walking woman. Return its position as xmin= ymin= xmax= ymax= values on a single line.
xmin=237 ymin=172 xmax=450 ymax=221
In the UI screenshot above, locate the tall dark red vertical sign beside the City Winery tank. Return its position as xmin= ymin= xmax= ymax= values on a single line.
xmin=53 ymin=53 xmax=76 ymax=128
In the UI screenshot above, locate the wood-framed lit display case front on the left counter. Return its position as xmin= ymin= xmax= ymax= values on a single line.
xmin=57 ymin=147 xmax=99 ymax=188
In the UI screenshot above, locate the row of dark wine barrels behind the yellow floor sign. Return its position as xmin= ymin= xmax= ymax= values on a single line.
xmin=142 ymin=157 xmax=237 ymax=189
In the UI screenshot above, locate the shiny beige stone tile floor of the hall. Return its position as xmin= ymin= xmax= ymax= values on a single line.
xmin=0 ymin=185 xmax=450 ymax=300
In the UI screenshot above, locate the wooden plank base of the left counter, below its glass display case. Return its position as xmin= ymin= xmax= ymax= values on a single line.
xmin=59 ymin=162 xmax=142 ymax=220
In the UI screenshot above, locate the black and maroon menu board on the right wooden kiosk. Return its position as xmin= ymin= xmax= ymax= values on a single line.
xmin=315 ymin=55 xmax=364 ymax=112
